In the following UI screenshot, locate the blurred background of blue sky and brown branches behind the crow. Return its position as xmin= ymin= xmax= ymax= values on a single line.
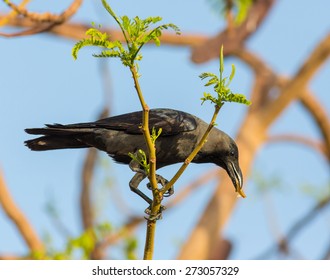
xmin=0 ymin=0 xmax=330 ymax=259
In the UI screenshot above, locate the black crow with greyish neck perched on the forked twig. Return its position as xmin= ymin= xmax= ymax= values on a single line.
xmin=25 ymin=109 xmax=245 ymax=204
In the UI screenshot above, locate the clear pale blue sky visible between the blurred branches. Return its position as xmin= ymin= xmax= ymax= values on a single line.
xmin=0 ymin=0 xmax=330 ymax=259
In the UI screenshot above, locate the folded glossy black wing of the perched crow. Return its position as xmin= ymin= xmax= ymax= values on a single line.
xmin=91 ymin=109 xmax=197 ymax=136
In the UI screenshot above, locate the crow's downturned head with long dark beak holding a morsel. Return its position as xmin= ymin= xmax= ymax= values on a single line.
xmin=205 ymin=129 xmax=246 ymax=198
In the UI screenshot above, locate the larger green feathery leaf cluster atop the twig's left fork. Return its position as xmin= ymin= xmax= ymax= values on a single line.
xmin=72 ymin=0 xmax=180 ymax=67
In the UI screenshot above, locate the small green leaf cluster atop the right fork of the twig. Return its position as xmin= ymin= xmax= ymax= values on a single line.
xmin=199 ymin=46 xmax=251 ymax=107
